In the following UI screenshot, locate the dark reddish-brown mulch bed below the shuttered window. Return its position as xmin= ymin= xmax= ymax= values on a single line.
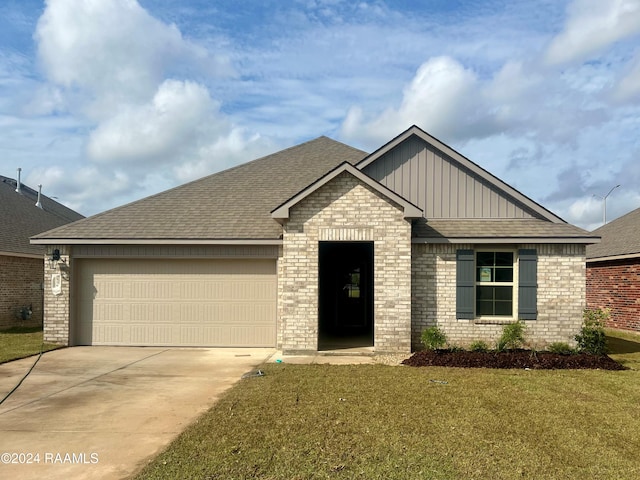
xmin=402 ymin=350 xmax=625 ymax=370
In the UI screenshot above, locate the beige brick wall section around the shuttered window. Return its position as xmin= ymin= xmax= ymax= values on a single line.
xmin=412 ymin=244 xmax=586 ymax=349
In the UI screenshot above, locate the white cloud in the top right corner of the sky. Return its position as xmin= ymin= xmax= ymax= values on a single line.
xmin=546 ymin=0 xmax=640 ymax=65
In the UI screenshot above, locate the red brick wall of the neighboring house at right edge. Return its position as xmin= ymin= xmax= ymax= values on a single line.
xmin=587 ymin=258 xmax=640 ymax=332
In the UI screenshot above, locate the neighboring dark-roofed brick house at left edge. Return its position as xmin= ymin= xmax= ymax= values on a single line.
xmin=0 ymin=175 xmax=84 ymax=328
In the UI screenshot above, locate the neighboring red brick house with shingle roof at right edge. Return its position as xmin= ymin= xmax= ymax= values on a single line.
xmin=587 ymin=208 xmax=640 ymax=332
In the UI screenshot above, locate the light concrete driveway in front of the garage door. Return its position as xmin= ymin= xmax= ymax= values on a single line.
xmin=0 ymin=347 xmax=274 ymax=479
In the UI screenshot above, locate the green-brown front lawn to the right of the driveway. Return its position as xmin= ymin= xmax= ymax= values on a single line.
xmin=136 ymin=333 xmax=640 ymax=480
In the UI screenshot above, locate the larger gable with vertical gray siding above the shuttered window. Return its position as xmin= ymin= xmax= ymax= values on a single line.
xmin=357 ymin=125 xmax=566 ymax=223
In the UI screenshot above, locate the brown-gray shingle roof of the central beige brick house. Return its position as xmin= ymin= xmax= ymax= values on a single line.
xmin=34 ymin=137 xmax=597 ymax=248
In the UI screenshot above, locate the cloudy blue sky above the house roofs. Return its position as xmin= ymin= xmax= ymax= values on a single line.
xmin=0 ymin=0 xmax=640 ymax=229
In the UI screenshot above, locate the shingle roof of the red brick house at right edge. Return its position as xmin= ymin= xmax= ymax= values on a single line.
xmin=587 ymin=204 xmax=640 ymax=262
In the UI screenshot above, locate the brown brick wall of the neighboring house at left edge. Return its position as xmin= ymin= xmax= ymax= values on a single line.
xmin=0 ymin=255 xmax=44 ymax=328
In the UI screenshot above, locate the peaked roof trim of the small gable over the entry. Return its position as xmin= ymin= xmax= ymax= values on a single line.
xmin=271 ymin=162 xmax=422 ymax=221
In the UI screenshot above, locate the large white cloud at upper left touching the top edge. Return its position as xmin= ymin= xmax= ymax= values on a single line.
xmin=34 ymin=0 xmax=232 ymax=118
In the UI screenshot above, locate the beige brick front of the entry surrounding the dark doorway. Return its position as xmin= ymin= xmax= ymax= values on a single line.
xmin=278 ymin=172 xmax=411 ymax=352
